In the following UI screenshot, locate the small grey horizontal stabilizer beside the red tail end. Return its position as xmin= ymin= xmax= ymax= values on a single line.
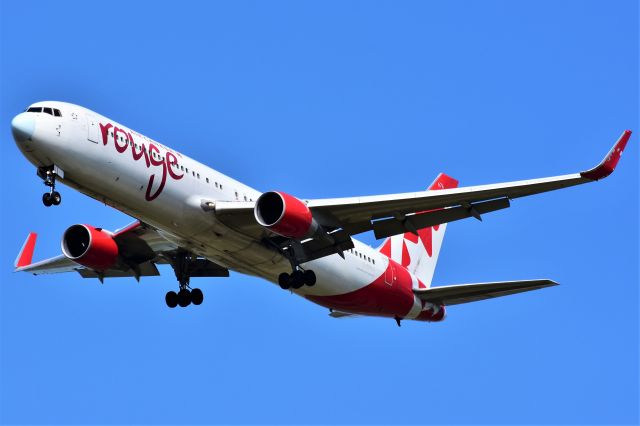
xmin=413 ymin=280 xmax=558 ymax=305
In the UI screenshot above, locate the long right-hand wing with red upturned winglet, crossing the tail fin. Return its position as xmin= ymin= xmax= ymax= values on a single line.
xmin=213 ymin=130 xmax=631 ymax=260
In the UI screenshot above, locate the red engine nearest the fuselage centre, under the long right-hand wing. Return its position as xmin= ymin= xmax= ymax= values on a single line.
xmin=254 ymin=191 xmax=318 ymax=239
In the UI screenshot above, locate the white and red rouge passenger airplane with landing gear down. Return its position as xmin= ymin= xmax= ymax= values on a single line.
xmin=11 ymin=101 xmax=631 ymax=326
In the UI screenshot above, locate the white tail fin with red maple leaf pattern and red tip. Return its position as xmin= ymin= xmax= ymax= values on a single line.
xmin=379 ymin=173 xmax=458 ymax=288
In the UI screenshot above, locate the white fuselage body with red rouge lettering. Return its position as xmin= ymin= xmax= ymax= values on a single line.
xmin=19 ymin=102 xmax=430 ymax=315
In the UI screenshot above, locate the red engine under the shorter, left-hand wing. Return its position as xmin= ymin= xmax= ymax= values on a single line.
xmin=62 ymin=225 xmax=118 ymax=271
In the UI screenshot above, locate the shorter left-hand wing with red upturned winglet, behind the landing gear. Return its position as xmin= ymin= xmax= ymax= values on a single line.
xmin=15 ymin=221 xmax=229 ymax=280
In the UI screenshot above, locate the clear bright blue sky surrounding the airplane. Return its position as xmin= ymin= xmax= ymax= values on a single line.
xmin=0 ymin=0 xmax=640 ymax=424
